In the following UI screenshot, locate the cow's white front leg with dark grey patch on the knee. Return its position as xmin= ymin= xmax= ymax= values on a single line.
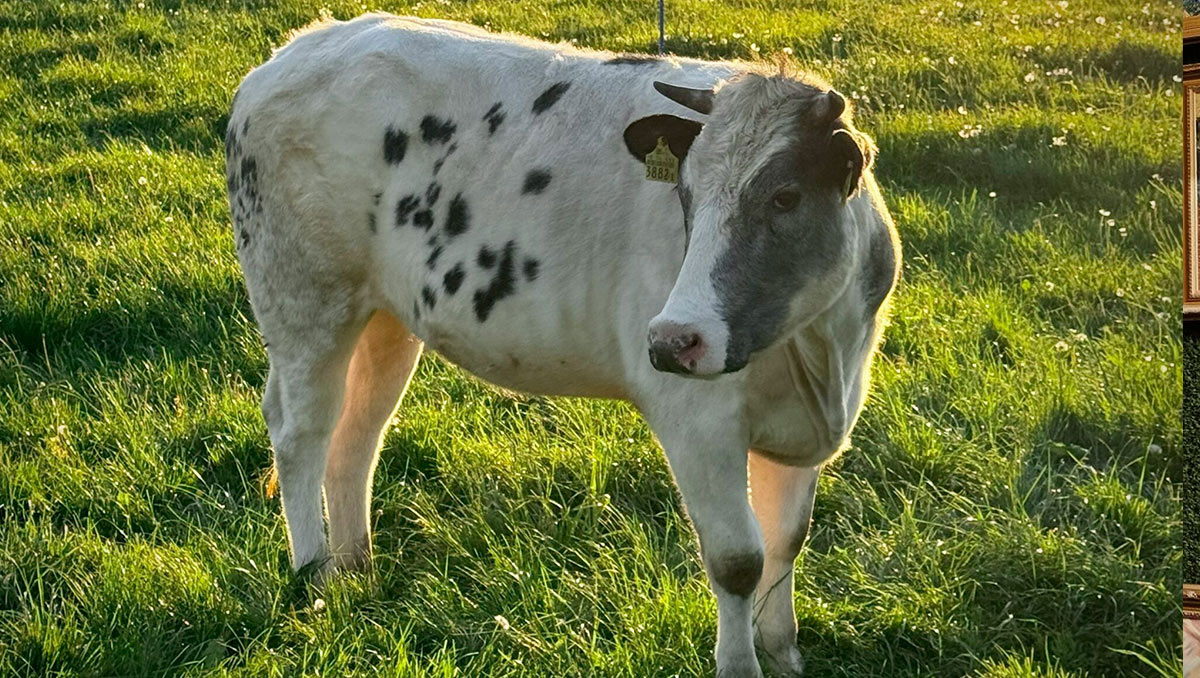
xmin=652 ymin=410 xmax=763 ymax=678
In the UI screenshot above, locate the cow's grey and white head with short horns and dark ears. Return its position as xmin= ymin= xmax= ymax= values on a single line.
xmin=625 ymin=73 xmax=874 ymax=376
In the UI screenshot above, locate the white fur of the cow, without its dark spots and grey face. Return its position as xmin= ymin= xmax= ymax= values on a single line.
xmin=230 ymin=14 xmax=888 ymax=677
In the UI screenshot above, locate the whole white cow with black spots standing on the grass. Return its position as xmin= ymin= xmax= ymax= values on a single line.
xmin=227 ymin=14 xmax=899 ymax=677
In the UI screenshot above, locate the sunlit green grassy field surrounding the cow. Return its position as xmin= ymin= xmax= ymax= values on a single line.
xmin=0 ymin=0 xmax=1180 ymax=678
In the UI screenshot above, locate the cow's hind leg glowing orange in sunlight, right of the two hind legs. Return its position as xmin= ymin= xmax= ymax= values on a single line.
xmin=325 ymin=311 xmax=421 ymax=570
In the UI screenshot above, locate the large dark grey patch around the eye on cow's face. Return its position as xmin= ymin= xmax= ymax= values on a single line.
xmin=712 ymin=145 xmax=847 ymax=372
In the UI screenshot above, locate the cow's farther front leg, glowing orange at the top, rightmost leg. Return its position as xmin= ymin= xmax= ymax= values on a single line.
xmin=749 ymin=450 xmax=821 ymax=677
